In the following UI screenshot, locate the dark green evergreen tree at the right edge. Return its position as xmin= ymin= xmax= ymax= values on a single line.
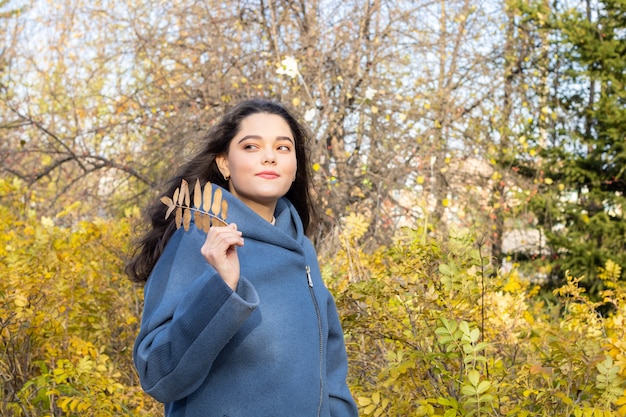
xmin=533 ymin=0 xmax=626 ymax=294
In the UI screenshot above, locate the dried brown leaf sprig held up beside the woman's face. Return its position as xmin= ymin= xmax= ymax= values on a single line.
xmin=161 ymin=179 xmax=228 ymax=232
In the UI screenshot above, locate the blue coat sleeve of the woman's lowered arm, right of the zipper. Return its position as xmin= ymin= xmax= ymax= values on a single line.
xmin=326 ymin=295 xmax=359 ymax=417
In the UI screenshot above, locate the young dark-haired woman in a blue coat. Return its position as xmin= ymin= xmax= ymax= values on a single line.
xmin=127 ymin=100 xmax=358 ymax=417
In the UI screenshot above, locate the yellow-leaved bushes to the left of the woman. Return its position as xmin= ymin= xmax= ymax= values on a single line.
xmin=0 ymin=180 xmax=162 ymax=417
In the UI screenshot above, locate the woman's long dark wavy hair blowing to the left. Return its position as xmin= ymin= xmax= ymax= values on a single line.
xmin=126 ymin=99 xmax=314 ymax=283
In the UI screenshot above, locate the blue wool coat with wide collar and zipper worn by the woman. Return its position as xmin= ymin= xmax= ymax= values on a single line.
xmin=133 ymin=186 xmax=358 ymax=417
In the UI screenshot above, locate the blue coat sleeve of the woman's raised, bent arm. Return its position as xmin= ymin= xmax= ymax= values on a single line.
xmin=133 ymin=223 xmax=259 ymax=403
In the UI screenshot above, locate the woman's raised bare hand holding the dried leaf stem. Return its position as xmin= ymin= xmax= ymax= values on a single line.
xmin=200 ymin=223 xmax=243 ymax=291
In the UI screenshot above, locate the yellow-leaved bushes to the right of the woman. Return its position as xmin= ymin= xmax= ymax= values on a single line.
xmin=322 ymin=231 xmax=626 ymax=417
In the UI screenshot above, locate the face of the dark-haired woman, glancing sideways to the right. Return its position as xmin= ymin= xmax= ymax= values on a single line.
xmin=216 ymin=113 xmax=297 ymax=216
